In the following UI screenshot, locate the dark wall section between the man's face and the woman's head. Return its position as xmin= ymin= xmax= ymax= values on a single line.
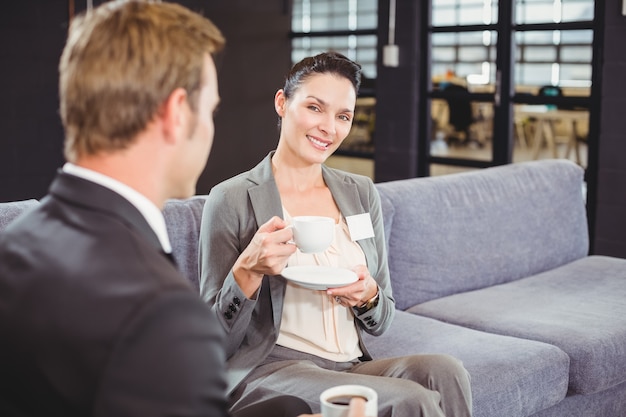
xmin=179 ymin=0 xmax=291 ymax=194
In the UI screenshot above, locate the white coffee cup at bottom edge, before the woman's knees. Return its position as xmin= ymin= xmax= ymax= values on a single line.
xmin=320 ymin=385 xmax=378 ymax=417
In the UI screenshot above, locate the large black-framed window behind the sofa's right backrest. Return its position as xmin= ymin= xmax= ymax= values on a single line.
xmin=426 ymin=0 xmax=592 ymax=175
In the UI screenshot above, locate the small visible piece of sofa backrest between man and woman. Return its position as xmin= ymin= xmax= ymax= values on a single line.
xmin=163 ymin=195 xmax=206 ymax=291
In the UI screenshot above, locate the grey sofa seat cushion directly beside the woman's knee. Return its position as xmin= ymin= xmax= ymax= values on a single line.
xmin=364 ymin=311 xmax=569 ymax=417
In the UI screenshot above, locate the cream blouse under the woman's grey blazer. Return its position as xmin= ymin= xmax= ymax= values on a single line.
xmin=276 ymin=207 xmax=366 ymax=362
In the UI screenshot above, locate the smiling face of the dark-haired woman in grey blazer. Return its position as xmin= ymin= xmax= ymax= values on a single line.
xmin=274 ymin=74 xmax=356 ymax=163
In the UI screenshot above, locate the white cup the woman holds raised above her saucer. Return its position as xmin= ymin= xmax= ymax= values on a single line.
xmin=292 ymin=216 xmax=335 ymax=253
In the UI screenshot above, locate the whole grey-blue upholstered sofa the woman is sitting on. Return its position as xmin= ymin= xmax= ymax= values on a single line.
xmin=0 ymin=160 xmax=626 ymax=417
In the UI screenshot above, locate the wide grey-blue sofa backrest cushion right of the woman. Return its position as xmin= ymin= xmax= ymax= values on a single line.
xmin=376 ymin=160 xmax=589 ymax=310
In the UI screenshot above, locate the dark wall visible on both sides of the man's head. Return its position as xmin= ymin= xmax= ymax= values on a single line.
xmin=0 ymin=0 xmax=291 ymax=201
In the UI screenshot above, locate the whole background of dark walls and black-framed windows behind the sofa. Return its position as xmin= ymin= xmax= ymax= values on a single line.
xmin=0 ymin=0 xmax=626 ymax=257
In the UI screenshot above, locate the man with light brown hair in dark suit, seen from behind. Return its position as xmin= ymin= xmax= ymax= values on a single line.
xmin=0 ymin=1 xmax=320 ymax=417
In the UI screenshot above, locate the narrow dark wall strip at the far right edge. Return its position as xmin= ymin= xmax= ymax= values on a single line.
xmin=593 ymin=0 xmax=626 ymax=258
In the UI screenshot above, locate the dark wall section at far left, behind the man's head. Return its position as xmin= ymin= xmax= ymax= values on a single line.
xmin=0 ymin=0 xmax=68 ymax=201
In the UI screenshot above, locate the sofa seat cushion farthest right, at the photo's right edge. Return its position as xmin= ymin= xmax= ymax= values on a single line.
xmin=408 ymin=256 xmax=626 ymax=394
